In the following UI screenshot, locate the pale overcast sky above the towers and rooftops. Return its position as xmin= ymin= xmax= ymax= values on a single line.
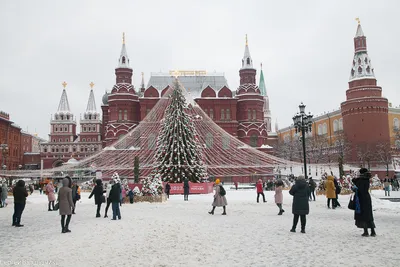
xmin=0 ymin=0 xmax=400 ymax=138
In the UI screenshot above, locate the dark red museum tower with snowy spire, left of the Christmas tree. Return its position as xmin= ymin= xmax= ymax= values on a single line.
xmin=102 ymin=33 xmax=140 ymax=149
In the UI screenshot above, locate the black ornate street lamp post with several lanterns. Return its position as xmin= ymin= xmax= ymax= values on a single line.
xmin=293 ymin=103 xmax=313 ymax=179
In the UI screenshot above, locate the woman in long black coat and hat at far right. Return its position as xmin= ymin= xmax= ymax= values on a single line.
xmin=353 ymin=168 xmax=376 ymax=236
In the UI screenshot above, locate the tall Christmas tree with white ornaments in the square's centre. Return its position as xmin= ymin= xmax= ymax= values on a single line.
xmin=142 ymin=80 xmax=207 ymax=195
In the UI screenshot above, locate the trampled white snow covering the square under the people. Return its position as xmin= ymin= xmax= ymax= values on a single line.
xmin=0 ymin=186 xmax=400 ymax=267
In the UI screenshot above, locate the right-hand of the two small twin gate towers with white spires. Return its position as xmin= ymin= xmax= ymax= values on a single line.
xmin=79 ymin=82 xmax=102 ymax=152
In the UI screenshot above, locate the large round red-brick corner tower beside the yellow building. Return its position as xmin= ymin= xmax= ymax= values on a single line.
xmin=341 ymin=19 xmax=390 ymax=162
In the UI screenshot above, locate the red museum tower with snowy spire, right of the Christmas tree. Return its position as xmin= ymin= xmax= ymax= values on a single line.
xmin=236 ymin=35 xmax=268 ymax=147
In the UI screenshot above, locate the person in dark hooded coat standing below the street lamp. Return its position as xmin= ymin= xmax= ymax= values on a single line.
xmin=289 ymin=175 xmax=310 ymax=234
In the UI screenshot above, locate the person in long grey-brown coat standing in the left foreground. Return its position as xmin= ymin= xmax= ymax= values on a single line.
xmin=58 ymin=178 xmax=75 ymax=234
